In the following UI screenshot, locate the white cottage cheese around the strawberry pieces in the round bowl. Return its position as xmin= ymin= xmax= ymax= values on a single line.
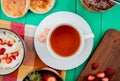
xmin=0 ymin=29 xmax=24 ymax=68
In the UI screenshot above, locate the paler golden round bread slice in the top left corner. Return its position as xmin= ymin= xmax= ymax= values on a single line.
xmin=1 ymin=0 xmax=30 ymax=18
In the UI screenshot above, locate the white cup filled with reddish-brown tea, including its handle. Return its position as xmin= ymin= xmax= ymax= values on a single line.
xmin=47 ymin=23 xmax=94 ymax=60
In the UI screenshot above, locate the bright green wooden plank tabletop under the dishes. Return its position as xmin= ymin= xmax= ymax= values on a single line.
xmin=0 ymin=0 xmax=120 ymax=81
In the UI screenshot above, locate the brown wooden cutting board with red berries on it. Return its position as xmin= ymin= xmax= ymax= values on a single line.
xmin=77 ymin=29 xmax=120 ymax=81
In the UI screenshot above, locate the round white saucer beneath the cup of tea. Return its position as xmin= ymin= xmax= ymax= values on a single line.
xmin=34 ymin=11 xmax=93 ymax=70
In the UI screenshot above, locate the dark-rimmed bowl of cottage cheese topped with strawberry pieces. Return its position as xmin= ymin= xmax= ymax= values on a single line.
xmin=0 ymin=28 xmax=25 ymax=75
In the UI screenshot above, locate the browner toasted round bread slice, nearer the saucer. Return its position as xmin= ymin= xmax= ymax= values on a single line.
xmin=30 ymin=0 xmax=55 ymax=14
